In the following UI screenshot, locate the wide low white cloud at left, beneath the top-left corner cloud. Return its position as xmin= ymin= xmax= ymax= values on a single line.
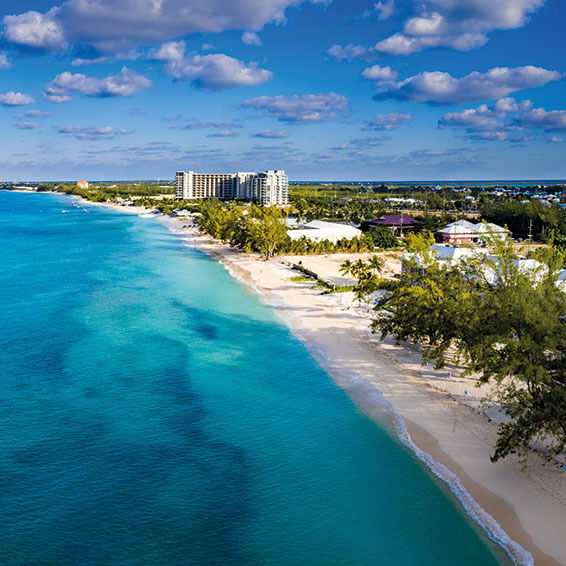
xmin=43 ymin=67 xmax=152 ymax=102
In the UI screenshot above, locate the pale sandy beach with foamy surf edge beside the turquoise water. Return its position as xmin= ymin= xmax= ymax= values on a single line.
xmin=168 ymin=221 xmax=566 ymax=565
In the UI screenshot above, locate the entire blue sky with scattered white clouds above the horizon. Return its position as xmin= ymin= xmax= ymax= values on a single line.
xmin=0 ymin=0 xmax=566 ymax=181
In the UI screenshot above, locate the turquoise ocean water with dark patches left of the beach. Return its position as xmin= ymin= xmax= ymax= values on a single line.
xmin=0 ymin=192 xmax=508 ymax=566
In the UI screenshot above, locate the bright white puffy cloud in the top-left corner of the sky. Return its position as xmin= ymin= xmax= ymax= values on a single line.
xmin=3 ymin=7 xmax=66 ymax=51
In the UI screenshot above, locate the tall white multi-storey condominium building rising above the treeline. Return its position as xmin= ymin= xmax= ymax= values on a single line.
xmin=175 ymin=169 xmax=289 ymax=205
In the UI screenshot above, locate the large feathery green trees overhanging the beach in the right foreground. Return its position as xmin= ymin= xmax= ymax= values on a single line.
xmin=372 ymin=237 xmax=566 ymax=461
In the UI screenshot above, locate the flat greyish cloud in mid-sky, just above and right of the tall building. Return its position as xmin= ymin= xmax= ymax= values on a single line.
xmin=242 ymin=92 xmax=348 ymax=124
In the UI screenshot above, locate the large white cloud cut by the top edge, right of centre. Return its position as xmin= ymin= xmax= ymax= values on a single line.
xmin=329 ymin=0 xmax=546 ymax=59
